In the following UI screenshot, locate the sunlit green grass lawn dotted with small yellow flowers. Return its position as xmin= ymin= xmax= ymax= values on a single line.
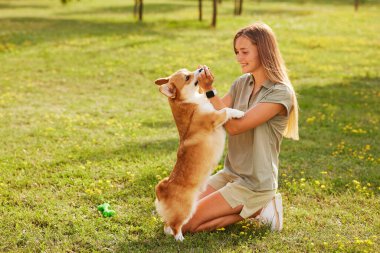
xmin=0 ymin=0 xmax=380 ymax=252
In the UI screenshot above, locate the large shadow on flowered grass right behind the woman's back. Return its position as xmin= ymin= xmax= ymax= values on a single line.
xmin=279 ymin=76 xmax=380 ymax=188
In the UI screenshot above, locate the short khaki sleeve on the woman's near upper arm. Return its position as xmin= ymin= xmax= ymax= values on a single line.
xmin=260 ymin=84 xmax=293 ymax=116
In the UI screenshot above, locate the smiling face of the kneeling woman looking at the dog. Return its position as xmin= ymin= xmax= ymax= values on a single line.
xmin=235 ymin=36 xmax=261 ymax=73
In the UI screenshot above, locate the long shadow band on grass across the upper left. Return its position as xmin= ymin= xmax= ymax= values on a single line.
xmin=0 ymin=17 xmax=209 ymax=47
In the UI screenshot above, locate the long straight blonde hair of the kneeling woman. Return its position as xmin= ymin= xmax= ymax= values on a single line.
xmin=234 ymin=22 xmax=299 ymax=140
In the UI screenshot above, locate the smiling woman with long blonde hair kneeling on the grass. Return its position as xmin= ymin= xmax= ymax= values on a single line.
xmin=183 ymin=23 xmax=298 ymax=233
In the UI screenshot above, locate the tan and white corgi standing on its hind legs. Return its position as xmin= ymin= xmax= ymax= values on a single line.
xmin=155 ymin=69 xmax=244 ymax=241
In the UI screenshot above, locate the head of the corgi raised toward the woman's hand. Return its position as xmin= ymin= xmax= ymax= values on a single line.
xmin=155 ymin=68 xmax=203 ymax=100
